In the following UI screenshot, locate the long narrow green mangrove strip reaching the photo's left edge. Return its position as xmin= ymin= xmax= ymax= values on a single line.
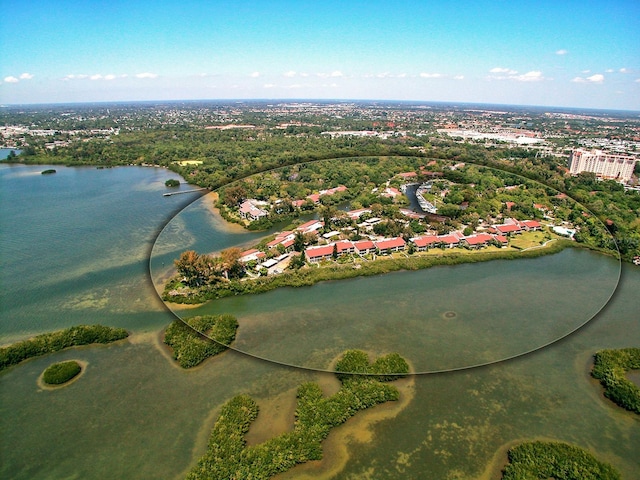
xmin=0 ymin=325 xmax=129 ymax=371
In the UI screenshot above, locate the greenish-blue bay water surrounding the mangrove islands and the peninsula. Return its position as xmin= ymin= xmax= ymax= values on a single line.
xmin=0 ymin=165 xmax=640 ymax=479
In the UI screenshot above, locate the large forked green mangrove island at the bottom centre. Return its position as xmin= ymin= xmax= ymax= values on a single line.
xmin=187 ymin=351 xmax=406 ymax=480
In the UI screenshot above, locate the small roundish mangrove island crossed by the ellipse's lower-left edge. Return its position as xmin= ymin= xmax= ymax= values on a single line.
xmin=164 ymin=315 xmax=238 ymax=368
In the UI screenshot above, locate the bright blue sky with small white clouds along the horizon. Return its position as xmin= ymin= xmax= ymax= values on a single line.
xmin=0 ymin=0 xmax=640 ymax=110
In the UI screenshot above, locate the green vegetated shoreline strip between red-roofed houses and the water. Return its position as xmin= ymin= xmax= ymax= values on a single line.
xmin=162 ymin=239 xmax=584 ymax=304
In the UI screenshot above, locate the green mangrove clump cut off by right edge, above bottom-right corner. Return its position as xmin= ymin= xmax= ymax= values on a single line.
xmin=591 ymin=348 xmax=640 ymax=414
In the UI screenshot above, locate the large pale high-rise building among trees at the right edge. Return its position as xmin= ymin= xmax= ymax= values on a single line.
xmin=569 ymin=148 xmax=638 ymax=182
